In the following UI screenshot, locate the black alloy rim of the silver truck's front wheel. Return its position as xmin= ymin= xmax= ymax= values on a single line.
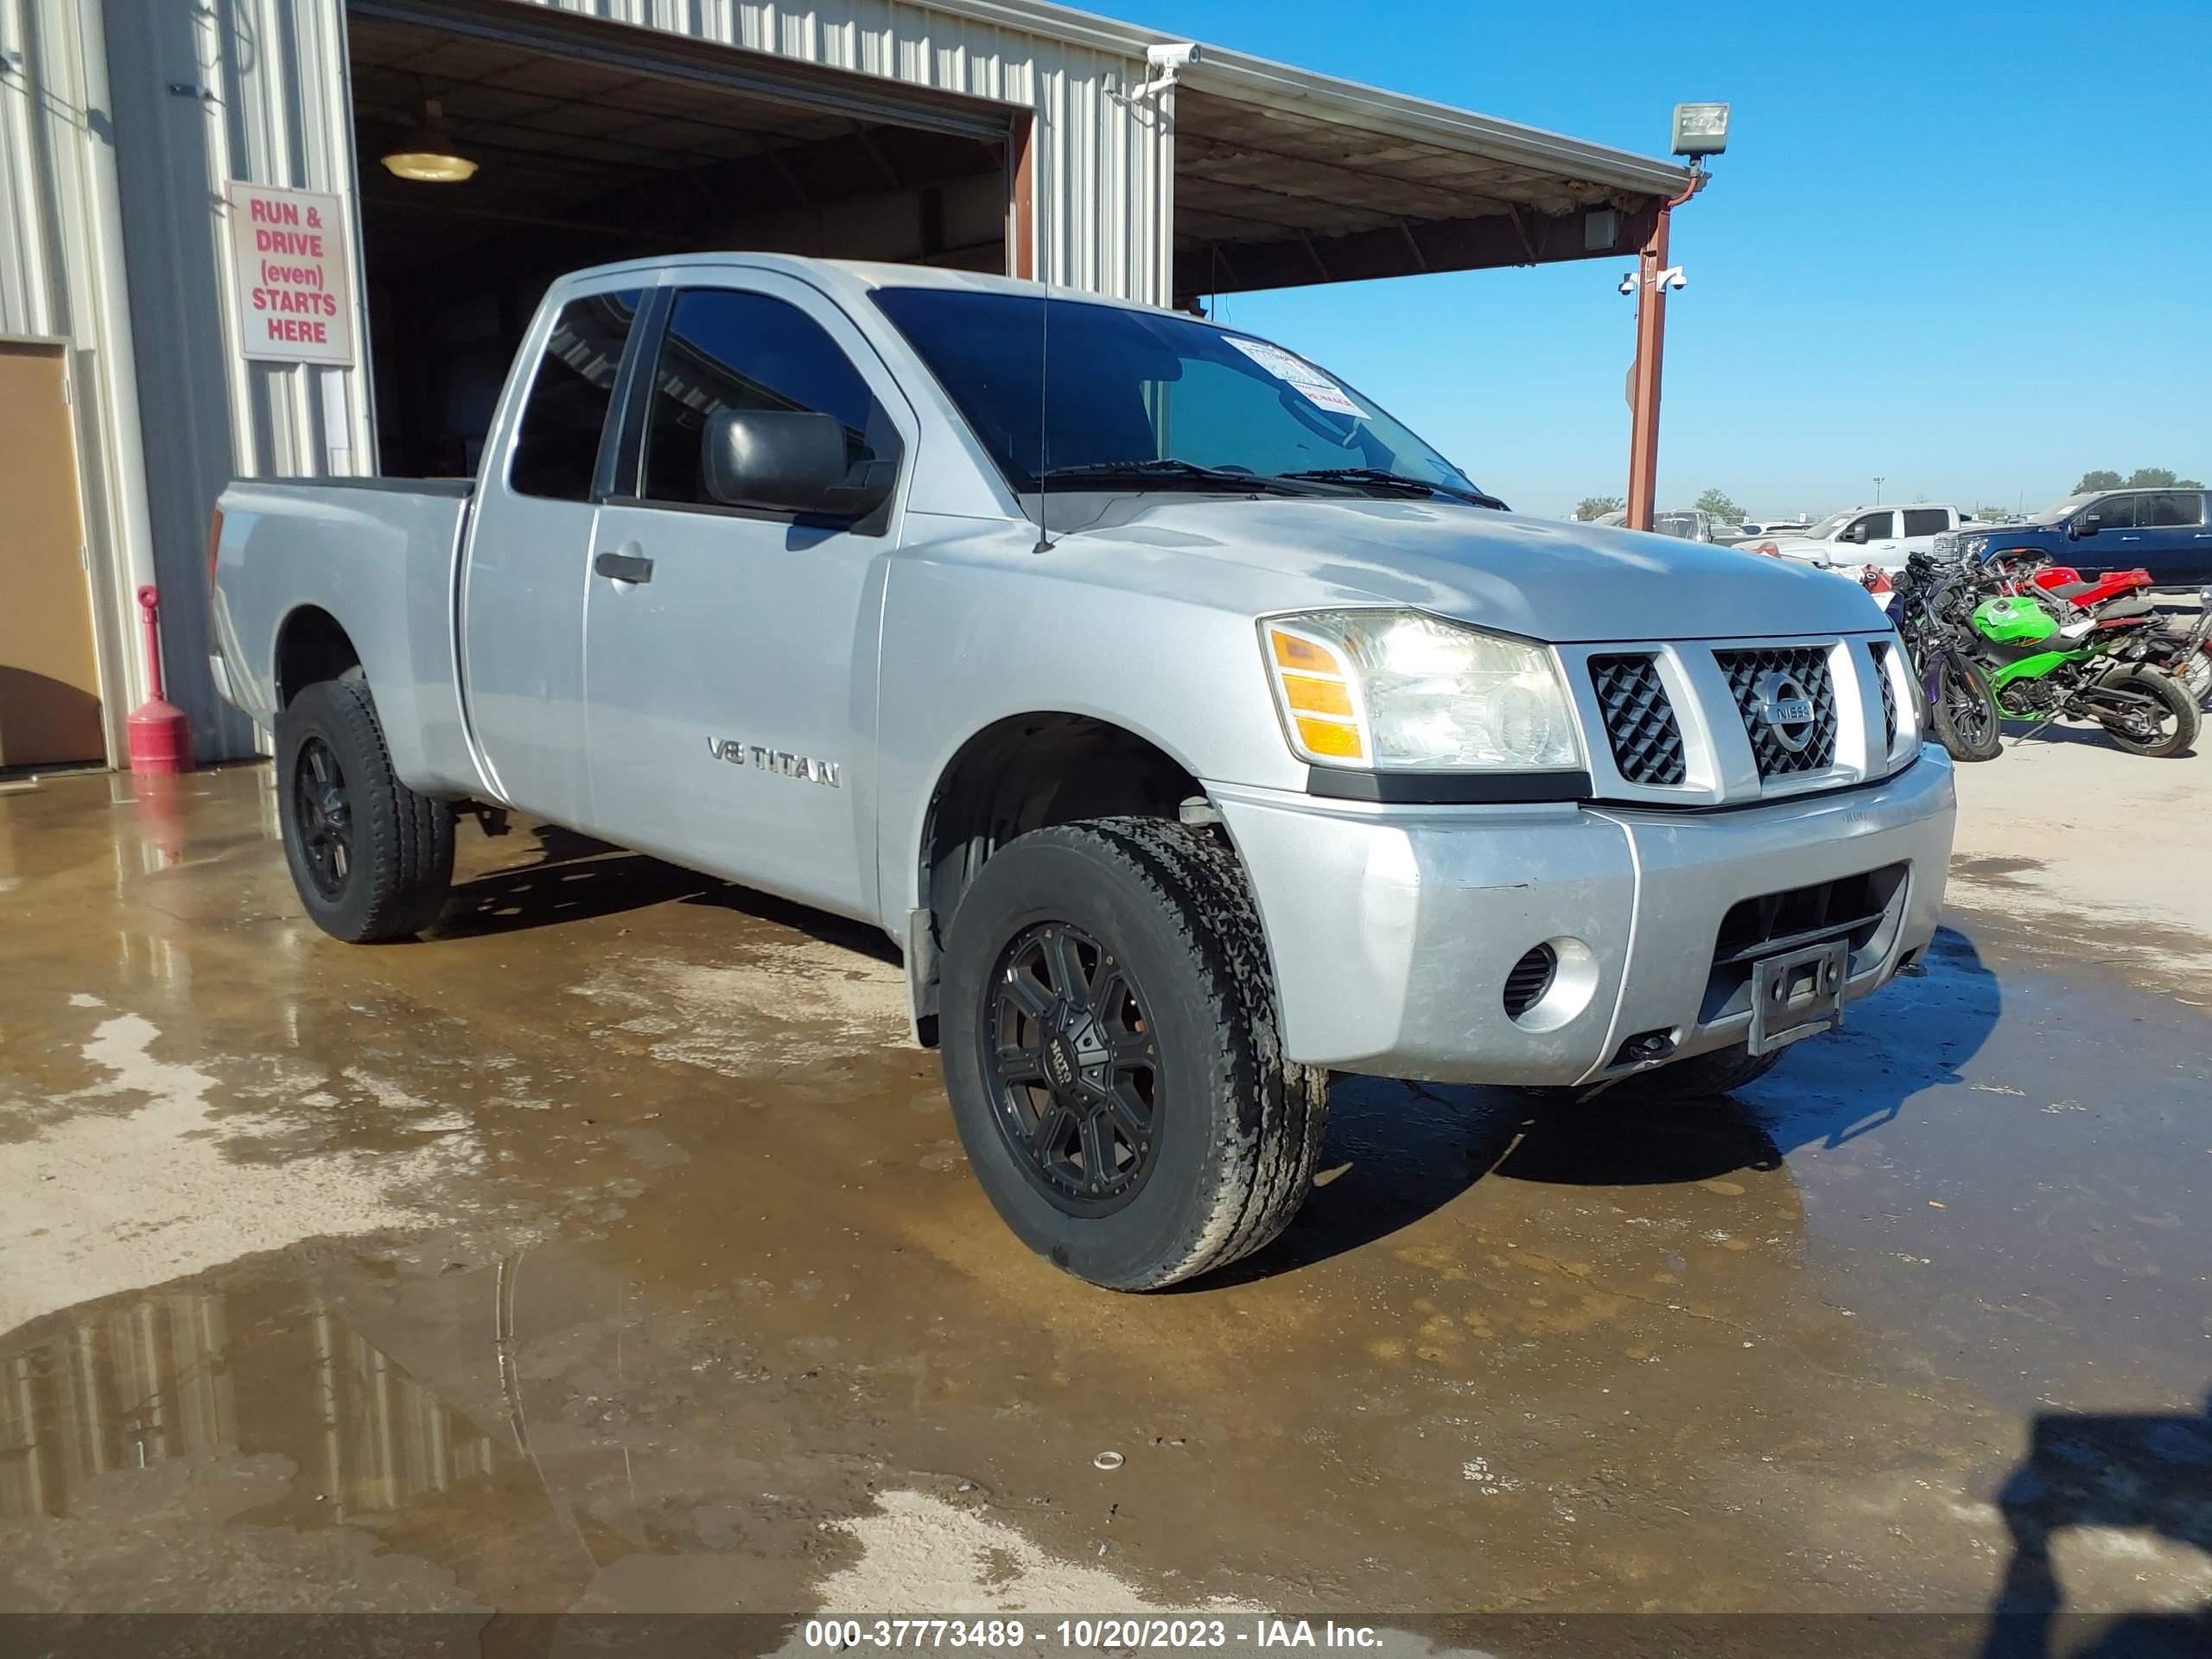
xmin=978 ymin=923 xmax=1159 ymax=1217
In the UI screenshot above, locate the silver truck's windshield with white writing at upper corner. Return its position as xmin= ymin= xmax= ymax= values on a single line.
xmin=876 ymin=288 xmax=1496 ymax=505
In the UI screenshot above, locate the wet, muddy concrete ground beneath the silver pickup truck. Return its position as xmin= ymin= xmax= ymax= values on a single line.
xmin=0 ymin=761 xmax=2212 ymax=1637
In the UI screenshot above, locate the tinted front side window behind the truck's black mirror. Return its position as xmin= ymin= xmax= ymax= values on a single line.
xmin=641 ymin=288 xmax=898 ymax=506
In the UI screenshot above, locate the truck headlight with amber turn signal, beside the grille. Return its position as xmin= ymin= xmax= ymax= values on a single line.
xmin=1259 ymin=611 xmax=1581 ymax=772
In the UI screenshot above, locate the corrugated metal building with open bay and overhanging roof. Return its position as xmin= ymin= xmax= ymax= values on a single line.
xmin=0 ymin=0 xmax=1688 ymax=767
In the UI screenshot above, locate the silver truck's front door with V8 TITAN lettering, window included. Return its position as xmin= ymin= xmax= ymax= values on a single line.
xmin=584 ymin=270 xmax=918 ymax=916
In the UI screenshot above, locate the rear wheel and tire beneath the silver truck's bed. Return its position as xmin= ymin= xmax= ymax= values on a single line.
xmin=276 ymin=675 xmax=454 ymax=944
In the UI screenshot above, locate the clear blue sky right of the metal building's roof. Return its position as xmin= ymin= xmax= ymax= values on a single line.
xmin=1123 ymin=0 xmax=2212 ymax=515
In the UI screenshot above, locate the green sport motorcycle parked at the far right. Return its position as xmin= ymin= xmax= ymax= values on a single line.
xmin=1960 ymin=595 xmax=2199 ymax=759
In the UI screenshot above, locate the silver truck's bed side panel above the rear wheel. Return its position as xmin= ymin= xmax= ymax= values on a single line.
xmin=214 ymin=478 xmax=482 ymax=797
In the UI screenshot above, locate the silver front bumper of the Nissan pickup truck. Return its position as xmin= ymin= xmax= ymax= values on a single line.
xmin=1210 ymin=746 xmax=1955 ymax=1084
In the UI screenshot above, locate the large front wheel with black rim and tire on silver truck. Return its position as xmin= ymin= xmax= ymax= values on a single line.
xmin=938 ymin=818 xmax=1327 ymax=1289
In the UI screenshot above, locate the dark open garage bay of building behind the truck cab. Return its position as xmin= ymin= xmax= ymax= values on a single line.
xmin=347 ymin=0 xmax=1027 ymax=475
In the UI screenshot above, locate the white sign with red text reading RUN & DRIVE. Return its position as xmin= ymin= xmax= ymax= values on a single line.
xmin=230 ymin=181 xmax=354 ymax=367
